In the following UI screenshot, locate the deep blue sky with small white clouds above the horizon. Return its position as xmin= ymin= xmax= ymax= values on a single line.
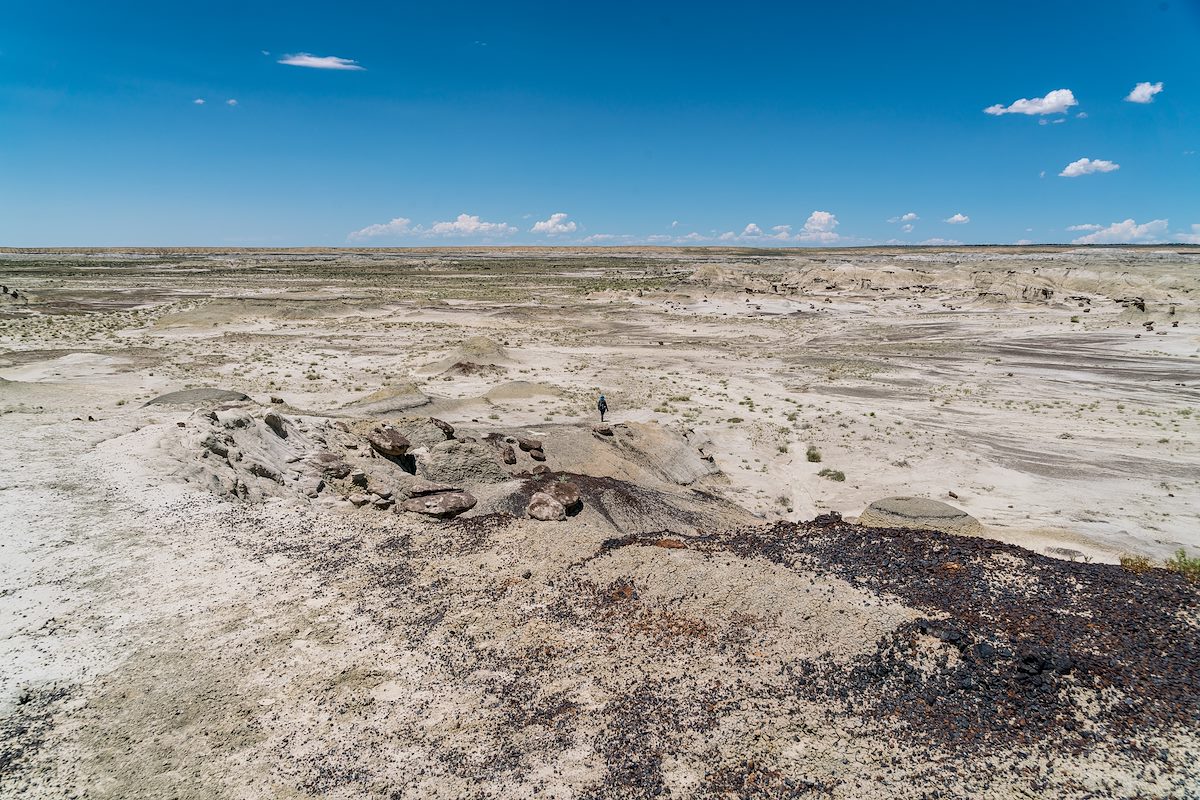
xmin=0 ymin=0 xmax=1200 ymax=247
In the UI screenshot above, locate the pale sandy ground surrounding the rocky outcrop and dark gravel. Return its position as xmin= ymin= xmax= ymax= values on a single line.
xmin=0 ymin=248 xmax=1200 ymax=798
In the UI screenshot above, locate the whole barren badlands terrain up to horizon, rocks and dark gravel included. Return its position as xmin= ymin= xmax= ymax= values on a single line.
xmin=0 ymin=247 xmax=1200 ymax=799
